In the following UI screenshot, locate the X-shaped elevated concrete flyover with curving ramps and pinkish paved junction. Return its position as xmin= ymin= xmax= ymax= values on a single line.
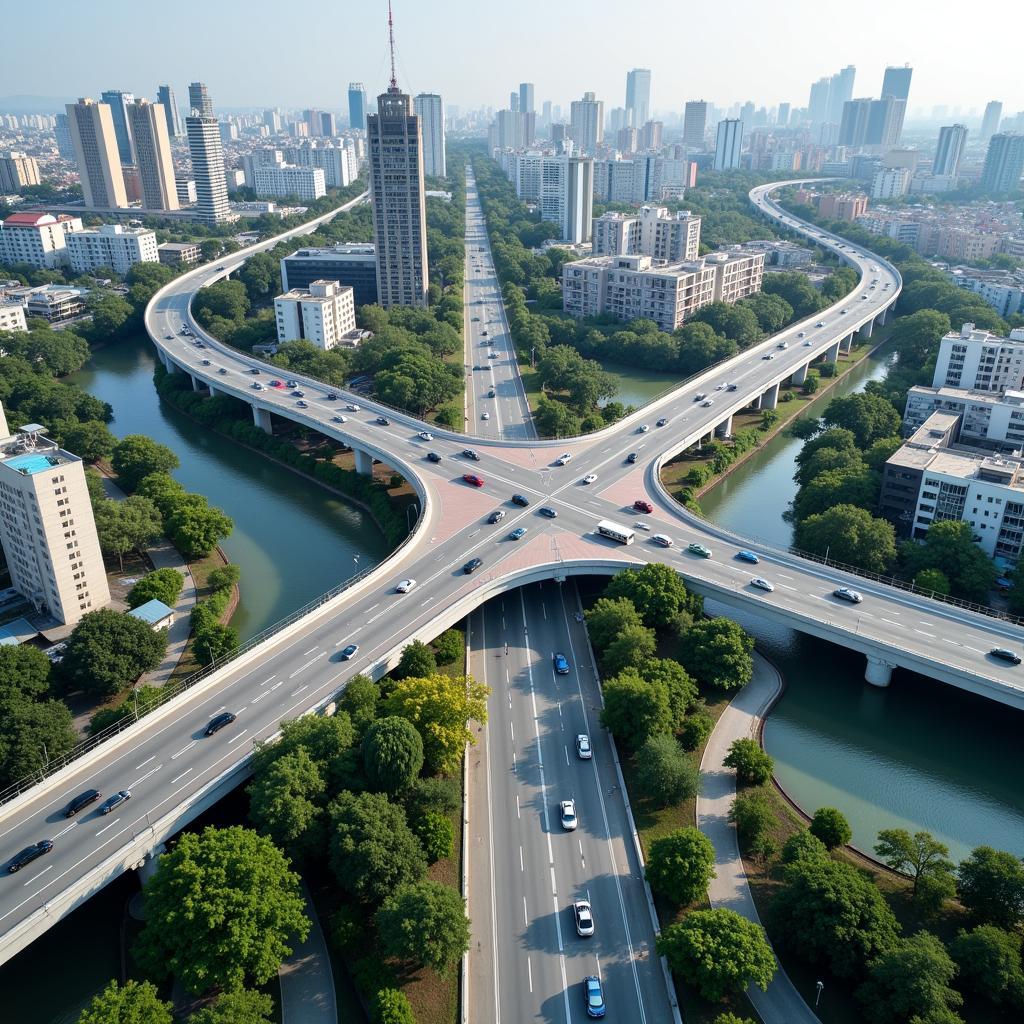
xmin=0 ymin=182 xmax=1024 ymax=978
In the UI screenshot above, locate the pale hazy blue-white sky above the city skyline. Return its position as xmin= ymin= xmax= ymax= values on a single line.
xmin=6 ymin=0 xmax=1024 ymax=114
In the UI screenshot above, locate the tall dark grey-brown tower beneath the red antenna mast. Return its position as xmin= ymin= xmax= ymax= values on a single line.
xmin=367 ymin=84 xmax=429 ymax=309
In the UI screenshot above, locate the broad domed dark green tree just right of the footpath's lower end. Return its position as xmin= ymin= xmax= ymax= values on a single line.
xmin=771 ymin=858 xmax=899 ymax=978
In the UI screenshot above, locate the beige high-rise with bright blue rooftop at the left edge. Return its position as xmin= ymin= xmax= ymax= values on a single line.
xmin=0 ymin=413 xmax=113 ymax=626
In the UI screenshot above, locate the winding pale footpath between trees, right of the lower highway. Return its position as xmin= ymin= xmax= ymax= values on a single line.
xmin=697 ymin=652 xmax=819 ymax=1024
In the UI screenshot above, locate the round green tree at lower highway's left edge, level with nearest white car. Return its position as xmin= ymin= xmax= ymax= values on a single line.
xmin=377 ymin=881 xmax=469 ymax=975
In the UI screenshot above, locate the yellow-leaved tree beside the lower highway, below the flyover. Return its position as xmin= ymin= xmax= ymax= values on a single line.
xmin=381 ymin=674 xmax=490 ymax=775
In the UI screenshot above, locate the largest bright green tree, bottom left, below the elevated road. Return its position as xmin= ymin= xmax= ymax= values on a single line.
xmin=133 ymin=825 xmax=309 ymax=993
